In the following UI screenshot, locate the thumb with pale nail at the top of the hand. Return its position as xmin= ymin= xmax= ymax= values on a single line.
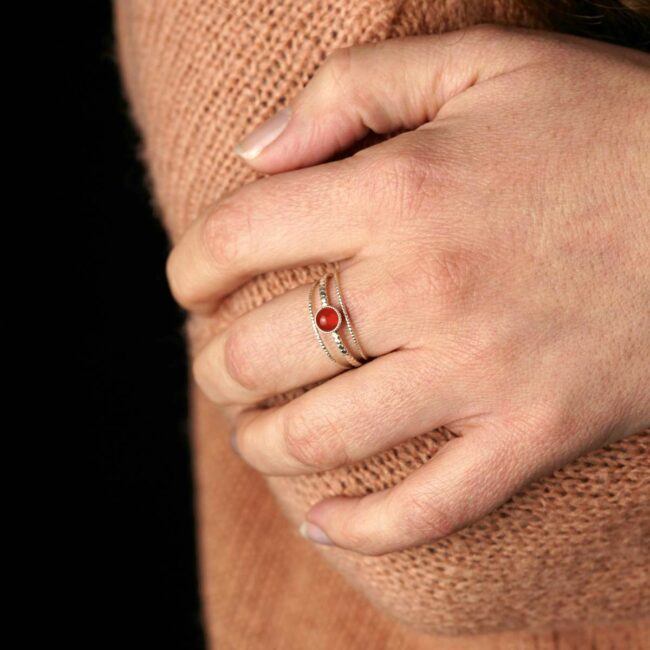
xmin=235 ymin=25 xmax=537 ymax=173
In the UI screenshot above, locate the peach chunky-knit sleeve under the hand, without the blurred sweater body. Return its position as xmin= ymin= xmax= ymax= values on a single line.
xmin=114 ymin=0 xmax=650 ymax=634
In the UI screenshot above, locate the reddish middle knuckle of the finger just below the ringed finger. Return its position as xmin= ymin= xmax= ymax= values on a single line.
xmin=282 ymin=411 xmax=347 ymax=469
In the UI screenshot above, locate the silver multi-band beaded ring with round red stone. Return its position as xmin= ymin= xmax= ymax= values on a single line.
xmin=308 ymin=269 xmax=368 ymax=368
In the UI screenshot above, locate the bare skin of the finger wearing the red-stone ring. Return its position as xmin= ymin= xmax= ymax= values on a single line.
xmin=192 ymin=261 xmax=422 ymax=404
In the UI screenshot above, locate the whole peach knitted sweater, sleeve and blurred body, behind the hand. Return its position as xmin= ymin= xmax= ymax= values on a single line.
xmin=116 ymin=0 xmax=650 ymax=648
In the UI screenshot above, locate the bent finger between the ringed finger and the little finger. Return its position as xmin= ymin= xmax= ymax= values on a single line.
xmin=230 ymin=349 xmax=465 ymax=476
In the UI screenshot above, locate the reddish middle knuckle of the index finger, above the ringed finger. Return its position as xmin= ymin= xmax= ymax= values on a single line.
xmin=200 ymin=202 xmax=251 ymax=268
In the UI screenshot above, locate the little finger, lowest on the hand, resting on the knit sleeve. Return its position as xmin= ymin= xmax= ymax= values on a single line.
xmin=301 ymin=418 xmax=579 ymax=555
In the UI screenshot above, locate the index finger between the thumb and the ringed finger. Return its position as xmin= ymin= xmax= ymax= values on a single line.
xmin=166 ymin=153 xmax=377 ymax=313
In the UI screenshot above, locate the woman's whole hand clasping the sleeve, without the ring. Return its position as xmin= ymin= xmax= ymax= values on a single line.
xmin=167 ymin=27 xmax=650 ymax=555
